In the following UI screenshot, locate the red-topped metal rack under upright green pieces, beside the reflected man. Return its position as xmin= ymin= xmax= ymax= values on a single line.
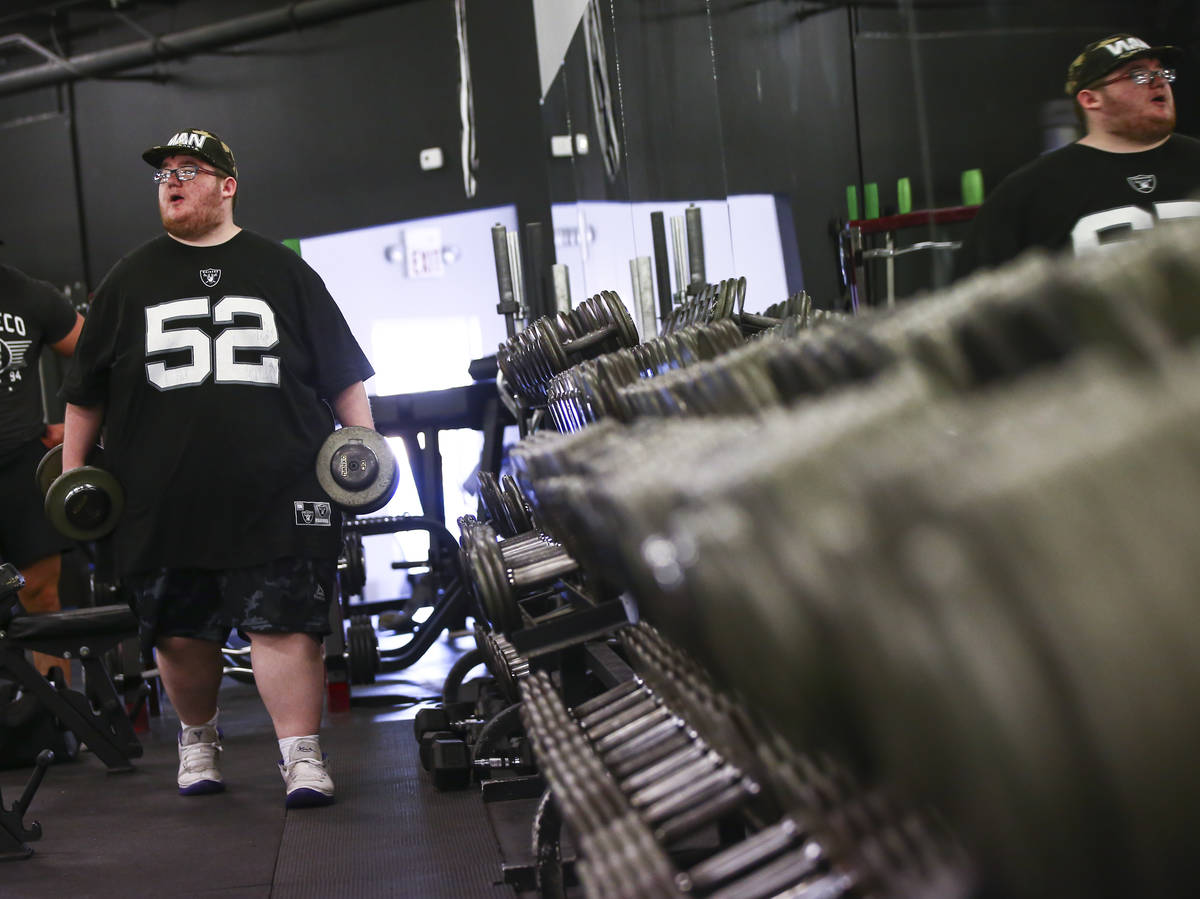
xmin=838 ymin=205 xmax=979 ymax=312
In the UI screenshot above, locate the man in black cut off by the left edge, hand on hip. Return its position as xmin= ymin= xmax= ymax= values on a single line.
xmin=0 ymin=265 xmax=83 ymax=683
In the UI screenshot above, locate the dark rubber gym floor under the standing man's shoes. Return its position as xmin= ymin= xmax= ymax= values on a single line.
xmin=0 ymin=640 xmax=516 ymax=899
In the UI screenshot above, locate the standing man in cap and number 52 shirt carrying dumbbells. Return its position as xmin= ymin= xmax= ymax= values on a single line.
xmin=61 ymin=128 xmax=373 ymax=808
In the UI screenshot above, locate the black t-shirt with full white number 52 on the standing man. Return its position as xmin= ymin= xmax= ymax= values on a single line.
xmin=60 ymin=230 xmax=373 ymax=574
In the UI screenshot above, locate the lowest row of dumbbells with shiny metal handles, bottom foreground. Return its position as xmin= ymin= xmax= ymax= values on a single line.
xmin=485 ymin=624 xmax=966 ymax=899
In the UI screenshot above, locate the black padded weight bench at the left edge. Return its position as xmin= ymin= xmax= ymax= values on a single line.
xmin=0 ymin=564 xmax=142 ymax=772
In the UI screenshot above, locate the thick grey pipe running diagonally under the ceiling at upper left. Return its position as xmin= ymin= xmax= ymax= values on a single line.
xmin=0 ymin=0 xmax=404 ymax=96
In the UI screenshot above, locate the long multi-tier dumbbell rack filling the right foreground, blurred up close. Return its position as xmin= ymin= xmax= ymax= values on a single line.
xmin=422 ymin=228 xmax=1200 ymax=898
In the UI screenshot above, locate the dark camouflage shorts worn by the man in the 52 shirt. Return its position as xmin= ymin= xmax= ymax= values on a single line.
xmin=125 ymin=558 xmax=337 ymax=649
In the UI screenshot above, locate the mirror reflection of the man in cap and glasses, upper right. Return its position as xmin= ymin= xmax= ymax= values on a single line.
xmin=955 ymin=35 xmax=1200 ymax=275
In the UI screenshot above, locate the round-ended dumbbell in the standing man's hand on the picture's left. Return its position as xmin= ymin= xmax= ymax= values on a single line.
xmin=35 ymin=444 xmax=125 ymax=541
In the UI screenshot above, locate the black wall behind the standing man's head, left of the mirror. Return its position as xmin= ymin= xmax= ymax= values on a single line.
xmin=0 ymin=0 xmax=548 ymax=287
